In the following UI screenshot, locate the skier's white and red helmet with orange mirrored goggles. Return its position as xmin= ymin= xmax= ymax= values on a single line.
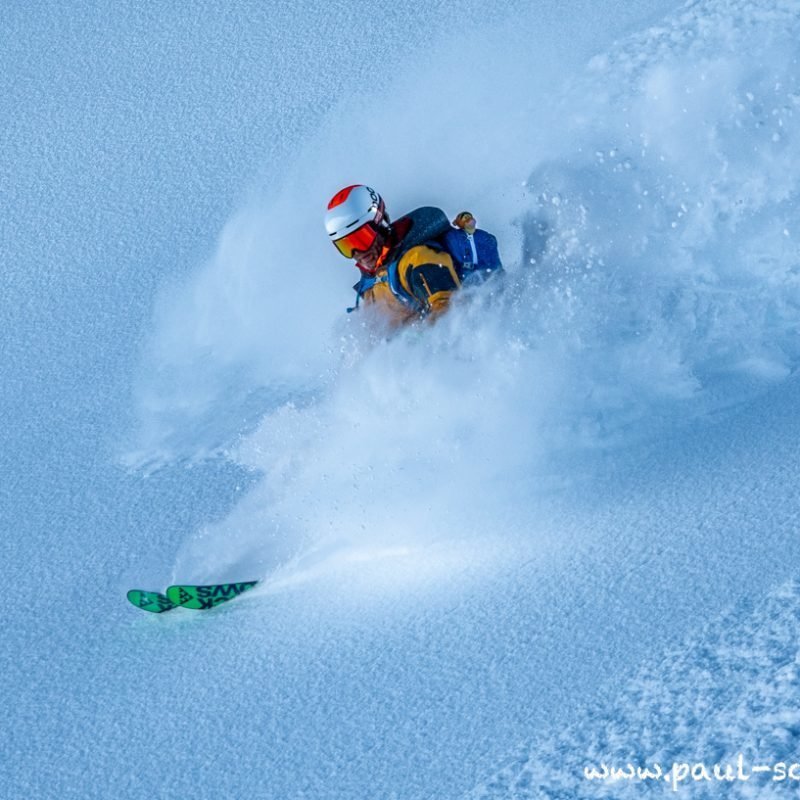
xmin=325 ymin=183 xmax=389 ymax=258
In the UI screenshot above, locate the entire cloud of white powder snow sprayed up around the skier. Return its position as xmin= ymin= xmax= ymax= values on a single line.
xmin=134 ymin=2 xmax=800 ymax=577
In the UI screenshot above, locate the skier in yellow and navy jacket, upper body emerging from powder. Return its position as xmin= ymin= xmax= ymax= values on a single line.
xmin=325 ymin=184 xmax=461 ymax=326
